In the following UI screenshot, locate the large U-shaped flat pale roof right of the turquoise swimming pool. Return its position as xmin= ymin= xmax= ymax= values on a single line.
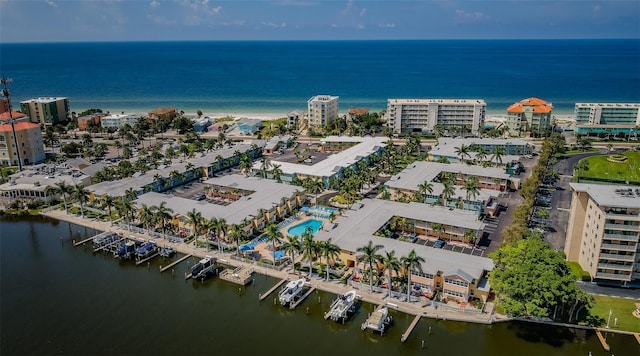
xmin=315 ymin=199 xmax=493 ymax=278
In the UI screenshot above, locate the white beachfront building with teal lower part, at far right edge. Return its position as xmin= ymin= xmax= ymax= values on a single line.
xmin=574 ymin=103 xmax=640 ymax=135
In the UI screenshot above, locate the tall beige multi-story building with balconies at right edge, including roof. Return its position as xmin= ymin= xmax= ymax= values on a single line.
xmin=564 ymin=183 xmax=640 ymax=287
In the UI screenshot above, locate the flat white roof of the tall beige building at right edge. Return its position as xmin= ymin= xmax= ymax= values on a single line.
xmin=569 ymin=183 xmax=640 ymax=209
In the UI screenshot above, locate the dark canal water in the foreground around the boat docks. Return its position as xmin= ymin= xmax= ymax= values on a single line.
xmin=0 ymin=213 xmax=640 ymax=356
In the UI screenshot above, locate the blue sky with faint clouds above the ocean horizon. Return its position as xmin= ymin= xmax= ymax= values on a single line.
xmin=0 ymin=0 xmax=640 ymax=43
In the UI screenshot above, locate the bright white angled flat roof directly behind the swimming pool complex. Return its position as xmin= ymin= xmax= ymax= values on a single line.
xmin=253 ymin=136 xmax=387 ymax=177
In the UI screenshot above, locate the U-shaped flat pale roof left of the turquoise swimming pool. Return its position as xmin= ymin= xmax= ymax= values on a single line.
xmin=135 ymin=174 xmax=299 ymax=224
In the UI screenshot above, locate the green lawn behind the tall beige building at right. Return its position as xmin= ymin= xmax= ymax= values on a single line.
xmin=574 ymin=151 xmax=640 ymax=183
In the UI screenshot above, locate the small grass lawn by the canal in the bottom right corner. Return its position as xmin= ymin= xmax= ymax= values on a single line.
xmin=591 ymin=295 xmax=640 ymax=332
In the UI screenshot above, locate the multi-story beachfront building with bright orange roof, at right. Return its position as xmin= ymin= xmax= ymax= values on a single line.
xmin=505 ymin=98 xmax=553 ymax=136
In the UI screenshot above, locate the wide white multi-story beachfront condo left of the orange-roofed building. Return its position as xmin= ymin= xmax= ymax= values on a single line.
xmin=386 ymin=99 xmax=487 ymax=133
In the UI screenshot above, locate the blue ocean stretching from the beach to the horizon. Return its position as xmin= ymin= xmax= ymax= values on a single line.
xmin=0 ymin=39 xmax=640 ymax=113
